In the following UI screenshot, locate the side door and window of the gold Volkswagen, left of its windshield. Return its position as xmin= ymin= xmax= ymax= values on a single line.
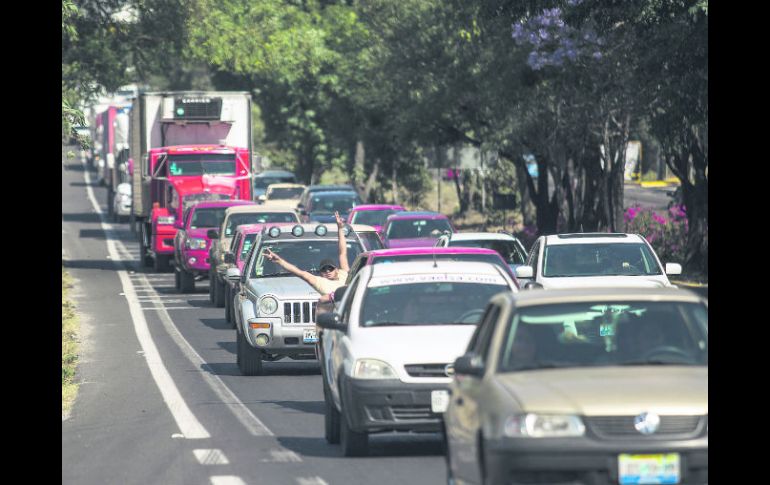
xmin=445 ymin=303 xmax=502 ymax=482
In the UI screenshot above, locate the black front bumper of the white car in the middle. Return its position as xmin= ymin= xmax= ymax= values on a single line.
xmin=340 ymin=376 xmax=449 ymax=432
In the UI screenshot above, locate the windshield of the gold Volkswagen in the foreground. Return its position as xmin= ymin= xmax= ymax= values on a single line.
xmin=499 ymin=301 xmax=708 ymax=372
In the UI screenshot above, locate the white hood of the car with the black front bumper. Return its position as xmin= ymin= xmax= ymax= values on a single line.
xmin=351 ymin=325 xmax=476 ymax=383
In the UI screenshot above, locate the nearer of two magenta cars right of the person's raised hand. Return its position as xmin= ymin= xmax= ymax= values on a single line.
xmin=382 ymin=211 xmax=455 ymax=248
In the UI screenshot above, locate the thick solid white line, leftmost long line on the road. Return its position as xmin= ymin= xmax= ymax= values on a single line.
xmin=83 ymin=165 xmax=211 ymax=439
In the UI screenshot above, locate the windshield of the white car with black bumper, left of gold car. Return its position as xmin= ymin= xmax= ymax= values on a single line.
xmin=360 ymin=281 xmax=508 ymax=327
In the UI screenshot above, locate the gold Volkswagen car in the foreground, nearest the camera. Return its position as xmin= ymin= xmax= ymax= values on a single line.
xmin=444 ymin=288 xmax=708 ymax=484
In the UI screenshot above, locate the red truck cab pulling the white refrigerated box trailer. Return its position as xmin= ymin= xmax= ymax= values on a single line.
xmin=140 ymin=145 xmax=251 ymax=271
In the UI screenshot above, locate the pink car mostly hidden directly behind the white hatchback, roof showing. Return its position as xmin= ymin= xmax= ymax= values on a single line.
xmin=345 ymin=247 xmax=519 ymax=288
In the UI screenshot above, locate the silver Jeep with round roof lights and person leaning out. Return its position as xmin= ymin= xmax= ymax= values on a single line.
xmin=227 ymin=224 xmax=363 ymax=375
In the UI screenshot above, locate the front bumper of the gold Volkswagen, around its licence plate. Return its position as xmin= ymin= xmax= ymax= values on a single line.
xmin=484 ymin=437 xmax=708 ymax=485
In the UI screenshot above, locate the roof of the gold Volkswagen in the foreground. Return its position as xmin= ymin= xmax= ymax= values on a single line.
xmin=504 ymin=287 xmax=705 ymax=306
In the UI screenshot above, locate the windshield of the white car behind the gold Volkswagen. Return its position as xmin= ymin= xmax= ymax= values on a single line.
xmin=543 ymin=243 xmax=662 ymax=278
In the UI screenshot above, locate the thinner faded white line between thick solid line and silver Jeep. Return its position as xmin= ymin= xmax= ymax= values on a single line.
xmin=116 ymin=241 xmax=274 ymax=438
